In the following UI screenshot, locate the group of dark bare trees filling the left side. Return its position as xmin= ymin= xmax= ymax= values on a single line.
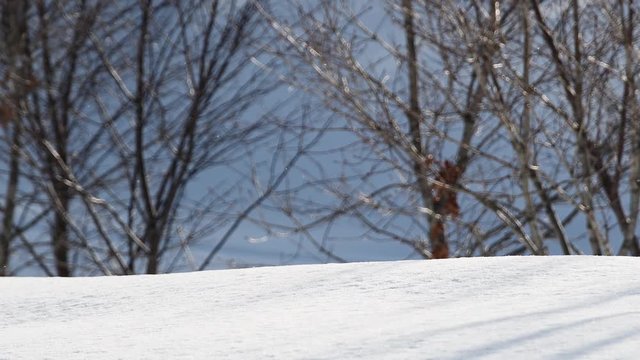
xmin=0 ymin=0 xmax=318 ymax=276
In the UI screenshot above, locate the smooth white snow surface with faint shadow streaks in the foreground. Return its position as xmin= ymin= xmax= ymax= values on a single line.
xmin=0 ymin=257 xmax=640 ymax=359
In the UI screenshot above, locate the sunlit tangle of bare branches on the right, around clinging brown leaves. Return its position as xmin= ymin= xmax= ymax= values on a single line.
xmin=257 ymin=0 xmax=640 ymax=260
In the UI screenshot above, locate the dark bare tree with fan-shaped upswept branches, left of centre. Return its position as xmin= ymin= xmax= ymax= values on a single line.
xmin=102 ymin=1 xmax=270 ymax=273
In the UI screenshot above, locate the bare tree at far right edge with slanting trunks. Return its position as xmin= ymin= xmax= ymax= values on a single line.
xmin=520 ymin=1 xmax=640 ymax=256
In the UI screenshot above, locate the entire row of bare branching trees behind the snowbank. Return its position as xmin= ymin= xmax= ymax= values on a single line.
xmin=0 ymin=0 xmax=640 ymax=276
